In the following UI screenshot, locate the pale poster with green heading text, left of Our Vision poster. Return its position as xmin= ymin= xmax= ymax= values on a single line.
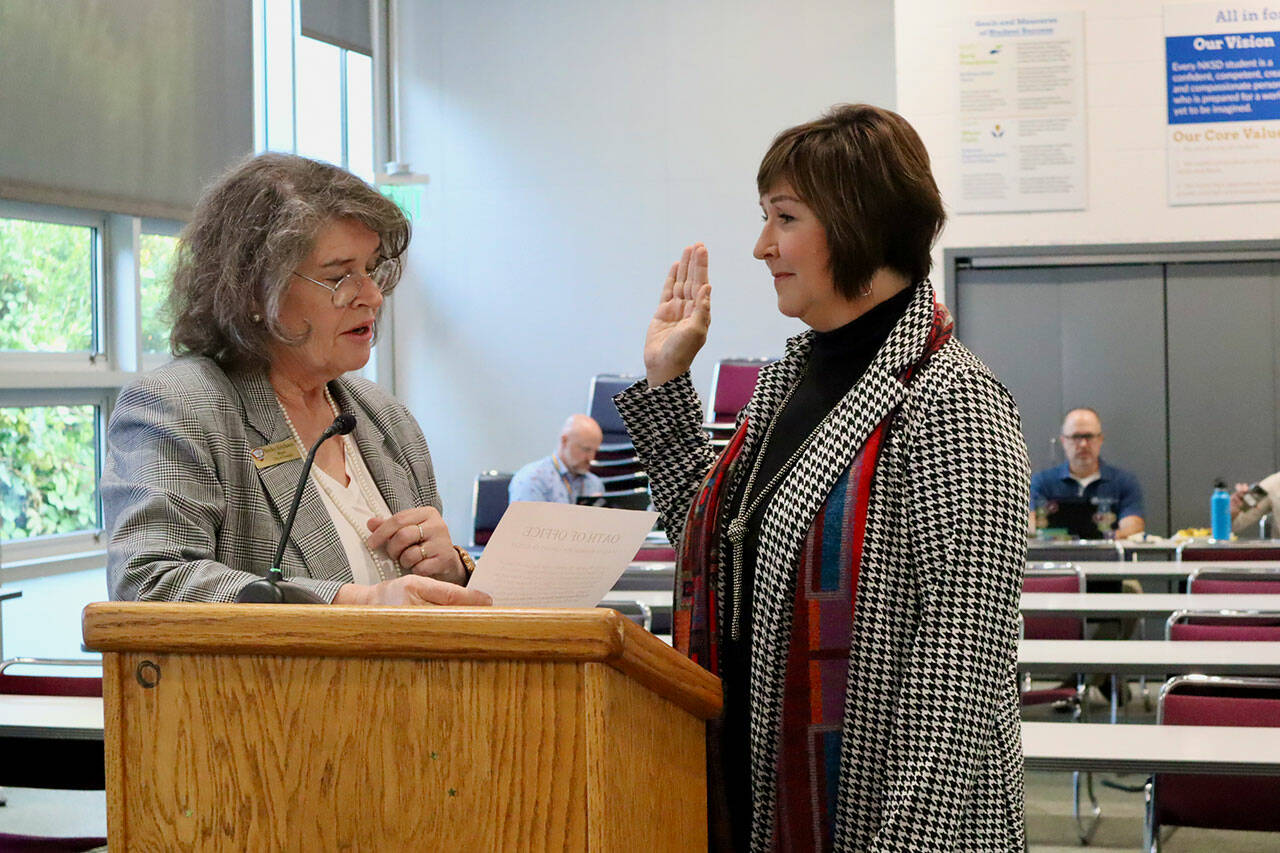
xmin=951 ymin=12 xmax=1085 ymax=213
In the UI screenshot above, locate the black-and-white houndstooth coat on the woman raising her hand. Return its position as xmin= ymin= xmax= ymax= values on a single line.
xmin=616 ymin=282 xmax=1029 ymax=850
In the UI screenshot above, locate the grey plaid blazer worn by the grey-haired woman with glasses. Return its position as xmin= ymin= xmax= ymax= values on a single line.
xmin=101 ymin=356 xmax=440 ymax=601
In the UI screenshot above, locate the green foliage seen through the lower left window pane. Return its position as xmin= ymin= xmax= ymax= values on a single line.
xmin=0 ymin=406 xmax=100 ymax=539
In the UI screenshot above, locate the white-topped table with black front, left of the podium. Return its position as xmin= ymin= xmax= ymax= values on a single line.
xmin=0 ymin=694 xmax=106 ymax=790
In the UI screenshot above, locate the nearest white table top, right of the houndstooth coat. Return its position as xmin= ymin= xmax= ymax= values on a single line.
xmin=1023 ymin=722 xmax=1280 ymax=776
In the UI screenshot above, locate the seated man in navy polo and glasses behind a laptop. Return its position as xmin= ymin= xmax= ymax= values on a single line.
xmin=1030 ymin=409 xmax=1147 ymax=539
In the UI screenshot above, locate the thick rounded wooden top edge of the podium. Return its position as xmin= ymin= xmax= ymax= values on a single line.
xmin=82 ymin=602 xmax=721 ymax=719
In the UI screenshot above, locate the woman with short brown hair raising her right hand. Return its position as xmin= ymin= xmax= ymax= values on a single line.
xmin=616 ymin=105 xmax=1028 ymax=850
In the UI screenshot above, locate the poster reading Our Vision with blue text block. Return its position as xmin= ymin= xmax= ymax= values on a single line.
xmin=1165 ymin=3 xmax=1280 ymax=205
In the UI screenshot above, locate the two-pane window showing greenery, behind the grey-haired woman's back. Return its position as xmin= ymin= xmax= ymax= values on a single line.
xmin=0 ymin=201 xmax=180 ymax=574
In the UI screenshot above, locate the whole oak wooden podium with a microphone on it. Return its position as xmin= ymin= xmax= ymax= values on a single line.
xmin=83 ymin=602 xmax=721 ymax=852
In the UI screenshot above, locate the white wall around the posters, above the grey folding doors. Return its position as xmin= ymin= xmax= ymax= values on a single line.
xmin=893 ymin=0 xmax=1280 ymax=270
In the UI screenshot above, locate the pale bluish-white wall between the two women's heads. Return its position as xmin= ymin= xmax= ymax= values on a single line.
xmin=392 ymin=0 xmax=895 ymax=542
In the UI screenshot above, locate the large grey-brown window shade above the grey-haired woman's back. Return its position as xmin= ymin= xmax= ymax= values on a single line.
xmin=0 ymin=0 xmax=253 ymax=219
